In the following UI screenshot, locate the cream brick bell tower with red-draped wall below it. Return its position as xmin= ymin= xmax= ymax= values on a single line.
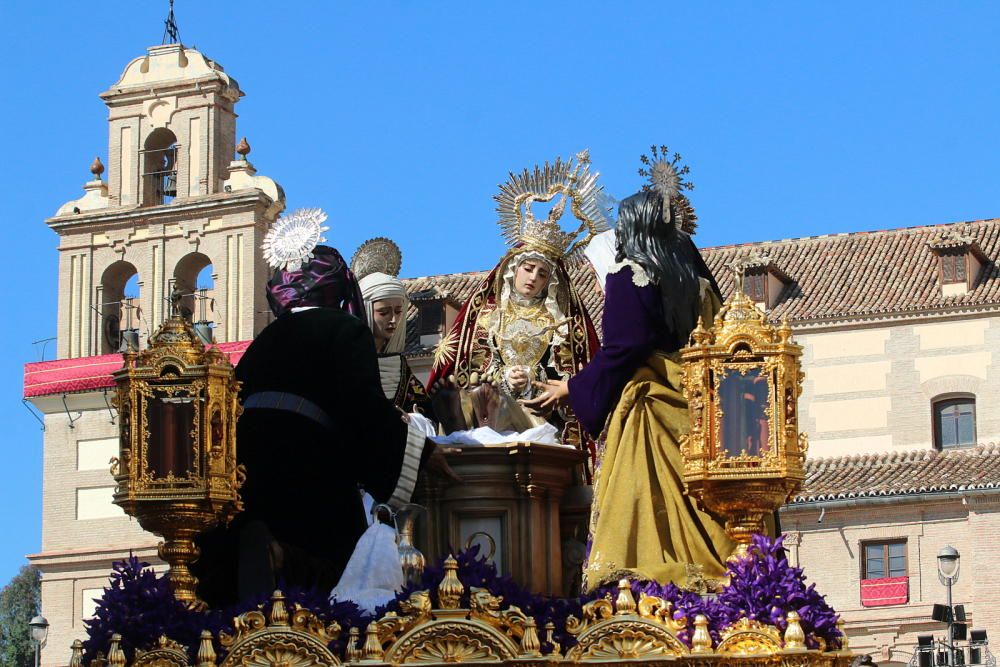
xmin=25 ymin=44 xmax=284 ymax=665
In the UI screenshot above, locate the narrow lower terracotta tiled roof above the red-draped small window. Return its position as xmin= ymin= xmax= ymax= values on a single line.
xmin=792 ymin=443 xmax=1000 ymax=504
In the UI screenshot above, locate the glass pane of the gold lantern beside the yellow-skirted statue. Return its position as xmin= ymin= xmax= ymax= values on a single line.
xmin=719 ymin=368 xmax=771 ymax=456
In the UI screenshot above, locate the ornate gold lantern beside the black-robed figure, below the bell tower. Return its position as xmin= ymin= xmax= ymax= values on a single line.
xmin=112 ymin=304 xmax=243 ymax=603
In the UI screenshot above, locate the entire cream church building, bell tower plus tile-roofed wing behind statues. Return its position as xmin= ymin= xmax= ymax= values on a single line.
xmin=25 ymin=40 xmax=1000 ymax=666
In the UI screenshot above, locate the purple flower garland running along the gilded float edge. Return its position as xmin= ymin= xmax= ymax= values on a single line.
xmin=83 ymin=535 xmax=840 ymax=664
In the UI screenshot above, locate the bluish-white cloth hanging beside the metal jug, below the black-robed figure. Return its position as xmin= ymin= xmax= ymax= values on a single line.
xmin=330 ymin=521 xmax=404 ymax=613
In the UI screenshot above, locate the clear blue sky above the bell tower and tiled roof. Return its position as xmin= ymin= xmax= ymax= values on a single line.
xmin=0 ymin=0 xmax=1000 ymax=582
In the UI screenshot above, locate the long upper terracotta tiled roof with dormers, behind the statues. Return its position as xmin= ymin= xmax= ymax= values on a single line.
xmin=403 ymin=218 xmax=1000 ymax=354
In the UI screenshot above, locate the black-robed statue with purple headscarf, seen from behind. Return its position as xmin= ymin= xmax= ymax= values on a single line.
xmin=196 ymin=247 xmax=433 ymax=607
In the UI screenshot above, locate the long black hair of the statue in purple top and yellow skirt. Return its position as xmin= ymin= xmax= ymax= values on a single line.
xmin=615 ymin=190 xmax=718 ymax=349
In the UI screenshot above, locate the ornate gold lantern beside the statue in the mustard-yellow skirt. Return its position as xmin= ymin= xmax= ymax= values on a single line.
xmin=681 ymin=270 xmax=807 ymax=552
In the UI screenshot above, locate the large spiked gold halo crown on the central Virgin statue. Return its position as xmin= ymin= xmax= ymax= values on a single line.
xmin=494 ymin=151 xmax=608 ymax=257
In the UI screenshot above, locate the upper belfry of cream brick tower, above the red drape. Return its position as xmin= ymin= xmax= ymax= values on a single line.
xmin=46 ymin=44 xmax=285 ymax=358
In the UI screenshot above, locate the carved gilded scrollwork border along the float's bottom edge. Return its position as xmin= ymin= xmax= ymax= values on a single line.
xmin=74 ymin=573 xmax=854 ymax=667
